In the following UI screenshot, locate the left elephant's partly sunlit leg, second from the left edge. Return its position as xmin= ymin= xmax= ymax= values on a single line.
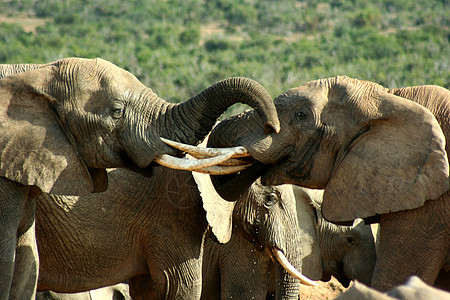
xmin=9 ymin=198 xmax=39 ymax=300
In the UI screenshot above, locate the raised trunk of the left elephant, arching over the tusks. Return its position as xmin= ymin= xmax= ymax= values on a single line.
xmin=162 ymin=77 xmax=280 ymax=144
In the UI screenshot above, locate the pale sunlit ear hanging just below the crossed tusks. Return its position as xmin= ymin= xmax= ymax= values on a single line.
xmin=192 ymin=172 xmax=236 ymax=244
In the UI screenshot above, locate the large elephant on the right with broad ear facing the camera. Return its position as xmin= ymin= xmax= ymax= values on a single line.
xmin=209 ymin=76 xmax=450 ymax=291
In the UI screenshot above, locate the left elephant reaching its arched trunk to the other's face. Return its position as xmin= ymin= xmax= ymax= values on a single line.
xmin=0 ymin=58 xmax=279 ymax=299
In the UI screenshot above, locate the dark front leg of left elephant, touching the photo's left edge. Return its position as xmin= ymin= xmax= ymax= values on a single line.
xmin=0 ymin=177 xmax=28 ymax=300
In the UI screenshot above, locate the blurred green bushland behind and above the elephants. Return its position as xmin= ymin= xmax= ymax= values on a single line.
xmin=0 ymin=0 xmax=450 ymax=115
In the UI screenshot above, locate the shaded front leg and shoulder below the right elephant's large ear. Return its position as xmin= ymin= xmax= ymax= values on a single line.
xmin=371 ymin=199 xmax=449 ymax=291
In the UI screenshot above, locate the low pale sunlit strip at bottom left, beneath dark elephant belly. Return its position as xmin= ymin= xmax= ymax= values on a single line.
xmin=36 ymin=283 xmax=131 ymax=300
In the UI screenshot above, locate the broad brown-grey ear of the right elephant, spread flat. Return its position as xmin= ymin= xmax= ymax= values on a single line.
xmin=322 ymin=90 xmax=449 ymax=224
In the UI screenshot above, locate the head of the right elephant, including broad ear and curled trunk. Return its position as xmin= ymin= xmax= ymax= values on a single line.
xmin=208 ymin=76 xmax=449 ymax=224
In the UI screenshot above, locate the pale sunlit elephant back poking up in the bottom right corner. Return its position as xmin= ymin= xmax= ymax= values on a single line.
xmin=336 ymin=276 xmax=450 ymax=300
